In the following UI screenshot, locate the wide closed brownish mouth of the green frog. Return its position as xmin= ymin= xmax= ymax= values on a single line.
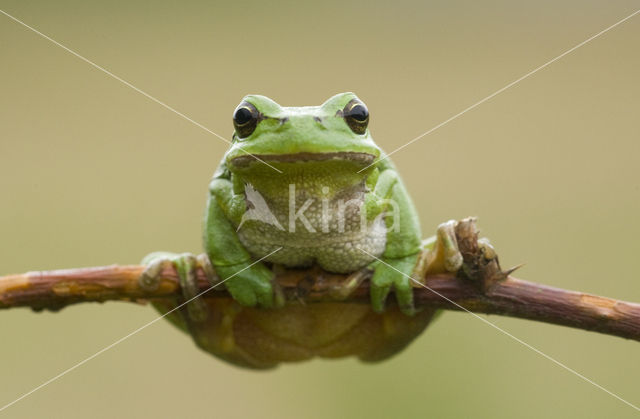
xmin=231 ymin=151 xmax=376 ymax=167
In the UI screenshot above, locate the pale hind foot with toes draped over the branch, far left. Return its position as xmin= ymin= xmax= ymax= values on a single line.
xmin=138 ymin=252 xmax=219 ymax=322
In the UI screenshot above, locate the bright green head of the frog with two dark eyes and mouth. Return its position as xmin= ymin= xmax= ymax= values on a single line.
xmin=225 ymin=93 xmax=380 ymax=173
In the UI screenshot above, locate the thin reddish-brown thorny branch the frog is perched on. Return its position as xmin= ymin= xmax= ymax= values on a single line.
xmin=0 ymin=265 xmax=640 ymax=341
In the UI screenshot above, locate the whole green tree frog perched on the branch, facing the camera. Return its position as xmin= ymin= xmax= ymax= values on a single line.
xmin=141 ymin=93 xmax=478 ymax=369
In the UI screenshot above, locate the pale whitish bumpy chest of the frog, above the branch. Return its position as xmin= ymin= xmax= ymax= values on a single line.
xmin=238 ymin=190 xmax=387 ymax=273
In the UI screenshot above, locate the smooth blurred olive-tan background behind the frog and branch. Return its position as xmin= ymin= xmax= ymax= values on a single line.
xmin=0 ymin=0 xmax=640 ymax=418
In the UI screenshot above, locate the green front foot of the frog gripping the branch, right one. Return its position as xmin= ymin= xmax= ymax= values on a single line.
xmin=370 ymin=254 xmax=419 ymax=315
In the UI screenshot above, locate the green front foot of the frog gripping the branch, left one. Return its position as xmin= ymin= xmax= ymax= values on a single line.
xmin=216 ymin=262 xmax=285 ymax=308
